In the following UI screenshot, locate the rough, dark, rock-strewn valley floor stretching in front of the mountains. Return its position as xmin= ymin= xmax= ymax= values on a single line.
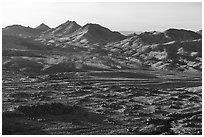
xmin=2 ymin=70 xmax=202 ymax=135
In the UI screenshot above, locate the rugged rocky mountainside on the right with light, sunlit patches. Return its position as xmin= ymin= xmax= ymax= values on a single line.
xmin=106 ymin=29 xmax=202 ymax=71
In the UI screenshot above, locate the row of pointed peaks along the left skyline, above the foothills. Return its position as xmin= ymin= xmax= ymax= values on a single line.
xmin=2 ymin=21 xmax=125 ymax=44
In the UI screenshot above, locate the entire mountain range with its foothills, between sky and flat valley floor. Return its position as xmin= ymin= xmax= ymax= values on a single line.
xmin=2 ymin=21 xmax=202 ymax=72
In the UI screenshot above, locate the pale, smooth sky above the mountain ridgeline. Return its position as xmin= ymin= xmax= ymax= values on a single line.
xmin=2 ymin=0 xmax=202 ymax=31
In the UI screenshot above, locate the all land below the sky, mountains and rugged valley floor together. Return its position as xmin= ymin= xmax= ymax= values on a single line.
xmin=2 ymin=1 xmax=202 ymax=135
